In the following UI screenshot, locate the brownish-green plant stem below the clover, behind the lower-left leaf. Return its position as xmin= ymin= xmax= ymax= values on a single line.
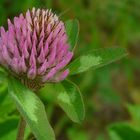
xmin=16 ymin=117 xmax=26 ymax=140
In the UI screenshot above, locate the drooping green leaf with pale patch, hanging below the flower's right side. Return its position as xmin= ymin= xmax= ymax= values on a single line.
xmin=57 ymin=80 xmax=85 ymax=123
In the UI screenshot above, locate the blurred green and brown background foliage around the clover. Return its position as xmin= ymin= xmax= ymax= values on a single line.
xmin=0 ymin=0 xmax=140 ymax=140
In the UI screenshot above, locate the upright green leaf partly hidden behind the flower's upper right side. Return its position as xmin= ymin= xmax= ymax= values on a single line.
xmin=65 ymin=19 xmax=79 ymax=50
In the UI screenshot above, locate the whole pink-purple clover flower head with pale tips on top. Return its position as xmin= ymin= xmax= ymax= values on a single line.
xmin=0 ymin=8 xmax=73 ymax=86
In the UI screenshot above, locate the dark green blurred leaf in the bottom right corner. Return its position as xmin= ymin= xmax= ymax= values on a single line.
xmin=109 ymin=123 xmax=140 ymax=140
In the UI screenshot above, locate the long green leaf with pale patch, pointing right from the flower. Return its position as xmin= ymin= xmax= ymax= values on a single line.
xmin=68 ymin=48 xmax=127 ymax=75
